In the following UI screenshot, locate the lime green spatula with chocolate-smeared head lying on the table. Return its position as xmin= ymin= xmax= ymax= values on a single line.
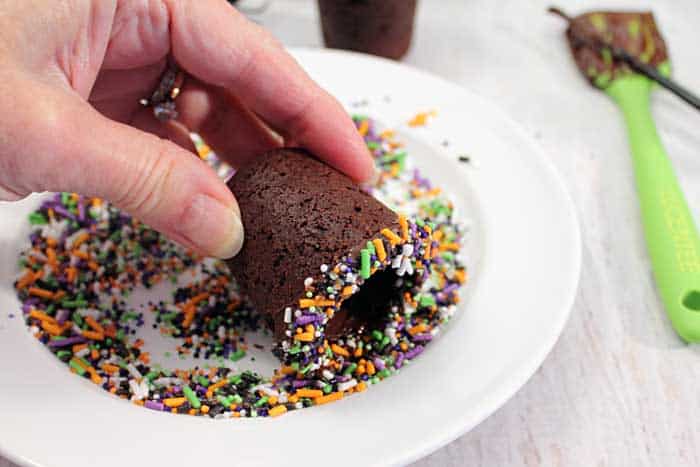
xmin=550 ymin=9 xmax=700 ymax=342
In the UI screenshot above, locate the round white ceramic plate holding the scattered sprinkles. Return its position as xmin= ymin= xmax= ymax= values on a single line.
xmin=0 ymin=50 xmax=580 ymax=467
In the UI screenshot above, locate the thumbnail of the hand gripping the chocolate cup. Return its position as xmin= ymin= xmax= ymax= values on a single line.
xmin=176 ymin=194 xmax=243 ymax=259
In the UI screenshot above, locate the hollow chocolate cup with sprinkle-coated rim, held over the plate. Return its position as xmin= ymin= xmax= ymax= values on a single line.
xmin=228 ymin=149 xmax=432 ymax=361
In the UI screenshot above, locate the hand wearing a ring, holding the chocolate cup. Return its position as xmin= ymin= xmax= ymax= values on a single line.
xmin=0 ymin=0 xmax=373 ymax=258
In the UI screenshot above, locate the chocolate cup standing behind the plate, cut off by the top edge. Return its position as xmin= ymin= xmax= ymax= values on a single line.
xmin=318 ymin=0 xmax=416 ymax=60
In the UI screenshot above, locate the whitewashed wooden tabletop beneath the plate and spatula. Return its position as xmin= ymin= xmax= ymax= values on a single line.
xmin=0 ymin=0 xmax=700 ymax=467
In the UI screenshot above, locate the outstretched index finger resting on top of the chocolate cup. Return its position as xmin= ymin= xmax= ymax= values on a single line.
xmin=166 ymin=0 xmax=374 ymax=181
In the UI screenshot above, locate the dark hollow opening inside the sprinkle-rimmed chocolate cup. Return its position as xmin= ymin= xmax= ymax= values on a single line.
xmin=326 ymin=268 xmax=404 ymax=338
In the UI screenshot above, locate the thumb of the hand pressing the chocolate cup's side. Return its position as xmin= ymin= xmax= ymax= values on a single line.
xmin=0 ymin=82 xmax=243 ymax=258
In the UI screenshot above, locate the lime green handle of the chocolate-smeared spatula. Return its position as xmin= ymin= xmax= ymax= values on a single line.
xmin=606 ymin=75 xmax=700 ymax=342
